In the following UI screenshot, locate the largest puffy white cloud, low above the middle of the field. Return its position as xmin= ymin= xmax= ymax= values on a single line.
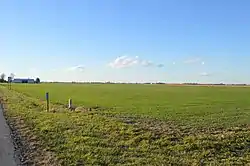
xmin=109 ymin=56 xmax=164 ymax=68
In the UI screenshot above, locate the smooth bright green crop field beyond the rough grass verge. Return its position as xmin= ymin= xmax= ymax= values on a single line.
xmin=13 ymin=84 xmax=250 ymax=125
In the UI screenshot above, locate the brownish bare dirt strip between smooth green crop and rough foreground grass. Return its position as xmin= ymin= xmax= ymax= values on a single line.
xmin=112 ymin=114 xmax=250 ymax=138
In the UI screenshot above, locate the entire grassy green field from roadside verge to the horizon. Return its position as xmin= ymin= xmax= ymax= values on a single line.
xmin=0 ymin=83 xmax=250 ymax=165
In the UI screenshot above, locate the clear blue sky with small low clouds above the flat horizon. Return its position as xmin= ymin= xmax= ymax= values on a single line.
xmin=0 ymin=0 xmax=250 ymax=83
